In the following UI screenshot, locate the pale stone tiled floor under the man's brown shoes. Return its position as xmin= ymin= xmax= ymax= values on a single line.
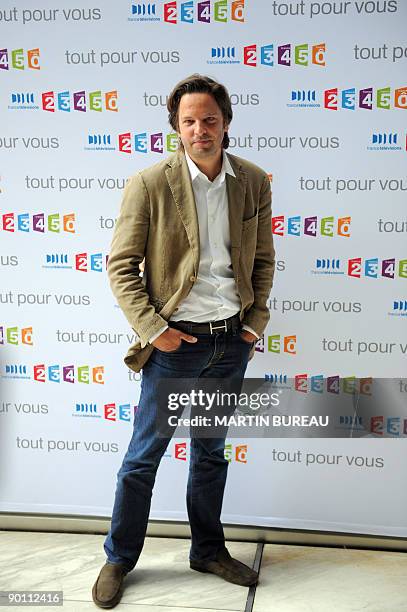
xmin=0 ymin=531 xmax=407 ymax=612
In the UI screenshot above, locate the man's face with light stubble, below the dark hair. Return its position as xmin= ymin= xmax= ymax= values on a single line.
xmin=178 ymin=93 xmax=228 ymax=162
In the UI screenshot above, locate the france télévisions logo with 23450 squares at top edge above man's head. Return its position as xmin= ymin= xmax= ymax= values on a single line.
xmin=128 ymin=0 xmax=245 ymax=26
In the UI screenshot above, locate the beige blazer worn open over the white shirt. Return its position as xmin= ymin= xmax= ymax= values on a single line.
xmin=108 ymin=151 xmax=275 ymax=372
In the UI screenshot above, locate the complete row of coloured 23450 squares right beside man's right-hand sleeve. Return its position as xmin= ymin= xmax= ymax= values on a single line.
xmin=271 ymin=215 xmax=351 ymax=238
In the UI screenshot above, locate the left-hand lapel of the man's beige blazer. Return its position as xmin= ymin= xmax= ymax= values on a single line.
xmin=165 ymin=152 xmax=200 ymax=275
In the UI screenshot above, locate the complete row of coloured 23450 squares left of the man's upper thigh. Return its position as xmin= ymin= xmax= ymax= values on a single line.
xmin=33 ymin=363 xmax=105 ymax=385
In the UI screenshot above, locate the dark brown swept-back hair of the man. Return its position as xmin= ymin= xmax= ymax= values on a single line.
xmin=167 ymin=74 xmax=233 ymax=149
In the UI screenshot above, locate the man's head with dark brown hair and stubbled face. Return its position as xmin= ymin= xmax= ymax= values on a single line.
xmin=167 ymin=74 xmax=233 ymax=160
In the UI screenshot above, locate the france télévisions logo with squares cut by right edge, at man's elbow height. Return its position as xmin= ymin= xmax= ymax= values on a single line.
xmin=311 ymin=257 xmax=407 ymax=279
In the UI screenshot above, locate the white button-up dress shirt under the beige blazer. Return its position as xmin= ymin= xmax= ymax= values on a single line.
xmin=150 ymin=151 xmax=257 ymax=343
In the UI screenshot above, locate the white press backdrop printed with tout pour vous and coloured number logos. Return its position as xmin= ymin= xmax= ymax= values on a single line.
xmin=0 ymin=0 xmax=407 ymax=536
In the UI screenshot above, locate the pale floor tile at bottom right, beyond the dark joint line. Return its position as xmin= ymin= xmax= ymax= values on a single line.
xmin=253 ymin=544 xmax=407 ymax=612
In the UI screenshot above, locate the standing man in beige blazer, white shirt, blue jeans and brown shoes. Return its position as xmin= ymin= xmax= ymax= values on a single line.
xmin=92 ymin=74 xmax=274 ymax=608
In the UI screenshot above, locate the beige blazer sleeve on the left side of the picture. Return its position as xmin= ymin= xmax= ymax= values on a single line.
xmin=107 ymin=174 xmax=167 ymax=348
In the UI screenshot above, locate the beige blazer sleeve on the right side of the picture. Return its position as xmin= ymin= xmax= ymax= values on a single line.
xmin=242 ymin=175 xmax=275 ymax=337
